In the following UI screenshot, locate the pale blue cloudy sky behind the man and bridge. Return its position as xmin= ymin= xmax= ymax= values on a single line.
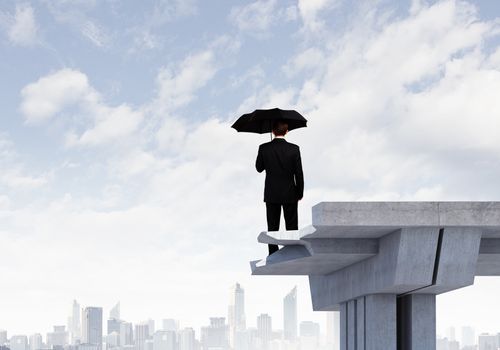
xmin=0 ymin=0 xmax=500 ymax=335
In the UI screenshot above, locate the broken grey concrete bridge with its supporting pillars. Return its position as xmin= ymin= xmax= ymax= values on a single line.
xmin=250 ymin=202 xmax=500 ymax=350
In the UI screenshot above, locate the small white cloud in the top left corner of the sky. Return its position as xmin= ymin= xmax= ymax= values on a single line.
xmin=7 ymin=4 xmax=38 ymax=46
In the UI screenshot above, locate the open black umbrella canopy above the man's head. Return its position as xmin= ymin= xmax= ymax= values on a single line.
xmin=231 ymin=108 xmax=307 ymax=134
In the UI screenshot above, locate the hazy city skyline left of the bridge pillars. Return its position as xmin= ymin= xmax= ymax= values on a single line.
xmin=0 ymin=283 xmax=330 ymax=350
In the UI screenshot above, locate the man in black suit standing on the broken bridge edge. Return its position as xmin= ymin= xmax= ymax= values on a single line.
xmin=255 ymin=121 xmax=304 ymax=255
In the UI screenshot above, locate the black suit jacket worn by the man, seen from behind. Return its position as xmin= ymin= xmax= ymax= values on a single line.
xmin=255 ymin=138 xmax=304 ymax=203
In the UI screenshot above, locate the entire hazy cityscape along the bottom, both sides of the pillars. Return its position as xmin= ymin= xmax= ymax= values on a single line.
xmin=0 ymin=283 xmax=500 ymax=350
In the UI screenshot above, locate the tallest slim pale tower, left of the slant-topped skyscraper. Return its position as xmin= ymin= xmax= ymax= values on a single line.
xmin=228 ymin=283 xmax=246 ymax=350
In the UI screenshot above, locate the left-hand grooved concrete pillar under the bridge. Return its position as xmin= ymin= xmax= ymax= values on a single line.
xmin=340 ymin=294 xmax=397 ymax=350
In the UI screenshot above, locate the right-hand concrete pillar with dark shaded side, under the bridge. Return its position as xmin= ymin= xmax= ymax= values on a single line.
xmin=397 ymin=294 xmax=436 ymax=350
